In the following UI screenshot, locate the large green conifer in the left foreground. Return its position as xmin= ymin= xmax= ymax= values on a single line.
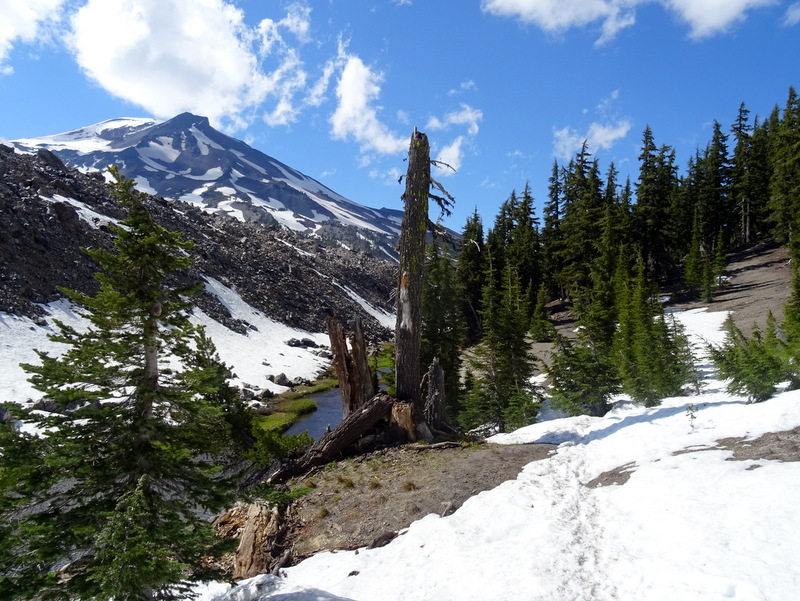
xmin=0 ymin=168 xmax=247 ymax=600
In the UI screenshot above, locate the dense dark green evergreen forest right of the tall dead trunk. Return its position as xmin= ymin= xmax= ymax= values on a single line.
xmin=422 ymin=88 xmax=800 ymax=431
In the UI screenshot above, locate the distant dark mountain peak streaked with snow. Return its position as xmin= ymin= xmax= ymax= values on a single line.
xmin=12 ymin=113 xmax=402 ymax=255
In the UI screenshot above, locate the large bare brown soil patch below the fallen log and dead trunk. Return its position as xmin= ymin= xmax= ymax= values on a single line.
xmin=282 ymin=444 xmax=555 ymax=557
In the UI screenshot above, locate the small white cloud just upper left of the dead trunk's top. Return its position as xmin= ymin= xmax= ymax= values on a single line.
xmin=330 ymin=55 xmax=408 ymax=154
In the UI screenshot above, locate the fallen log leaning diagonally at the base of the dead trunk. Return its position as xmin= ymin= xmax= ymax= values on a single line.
xmin=267 ymin=392 xmax=395 ymax=484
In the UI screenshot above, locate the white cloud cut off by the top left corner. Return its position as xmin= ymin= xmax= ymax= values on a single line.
xmin=0 ymin=0 xmax=64 ymax=75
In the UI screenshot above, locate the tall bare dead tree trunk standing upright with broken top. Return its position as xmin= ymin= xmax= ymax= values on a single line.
xmin=395 ymin=129 xmax=431 ymax=422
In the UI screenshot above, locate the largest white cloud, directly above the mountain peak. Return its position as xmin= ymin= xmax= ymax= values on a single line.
xmin=69 ymin=0 xmax=309 ymax=129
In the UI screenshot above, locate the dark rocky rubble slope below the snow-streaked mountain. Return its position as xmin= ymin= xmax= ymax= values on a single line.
xmin=0 ymin=145 xmax=395 ymax=339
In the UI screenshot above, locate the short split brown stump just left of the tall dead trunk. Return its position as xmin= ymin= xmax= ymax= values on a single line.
xmin=325 ymin=317 xmax=375 ymax=418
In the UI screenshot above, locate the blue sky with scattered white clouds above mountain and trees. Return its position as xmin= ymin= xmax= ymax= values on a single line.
xmin=0 ymin=0 xmax=800 ymax=229
